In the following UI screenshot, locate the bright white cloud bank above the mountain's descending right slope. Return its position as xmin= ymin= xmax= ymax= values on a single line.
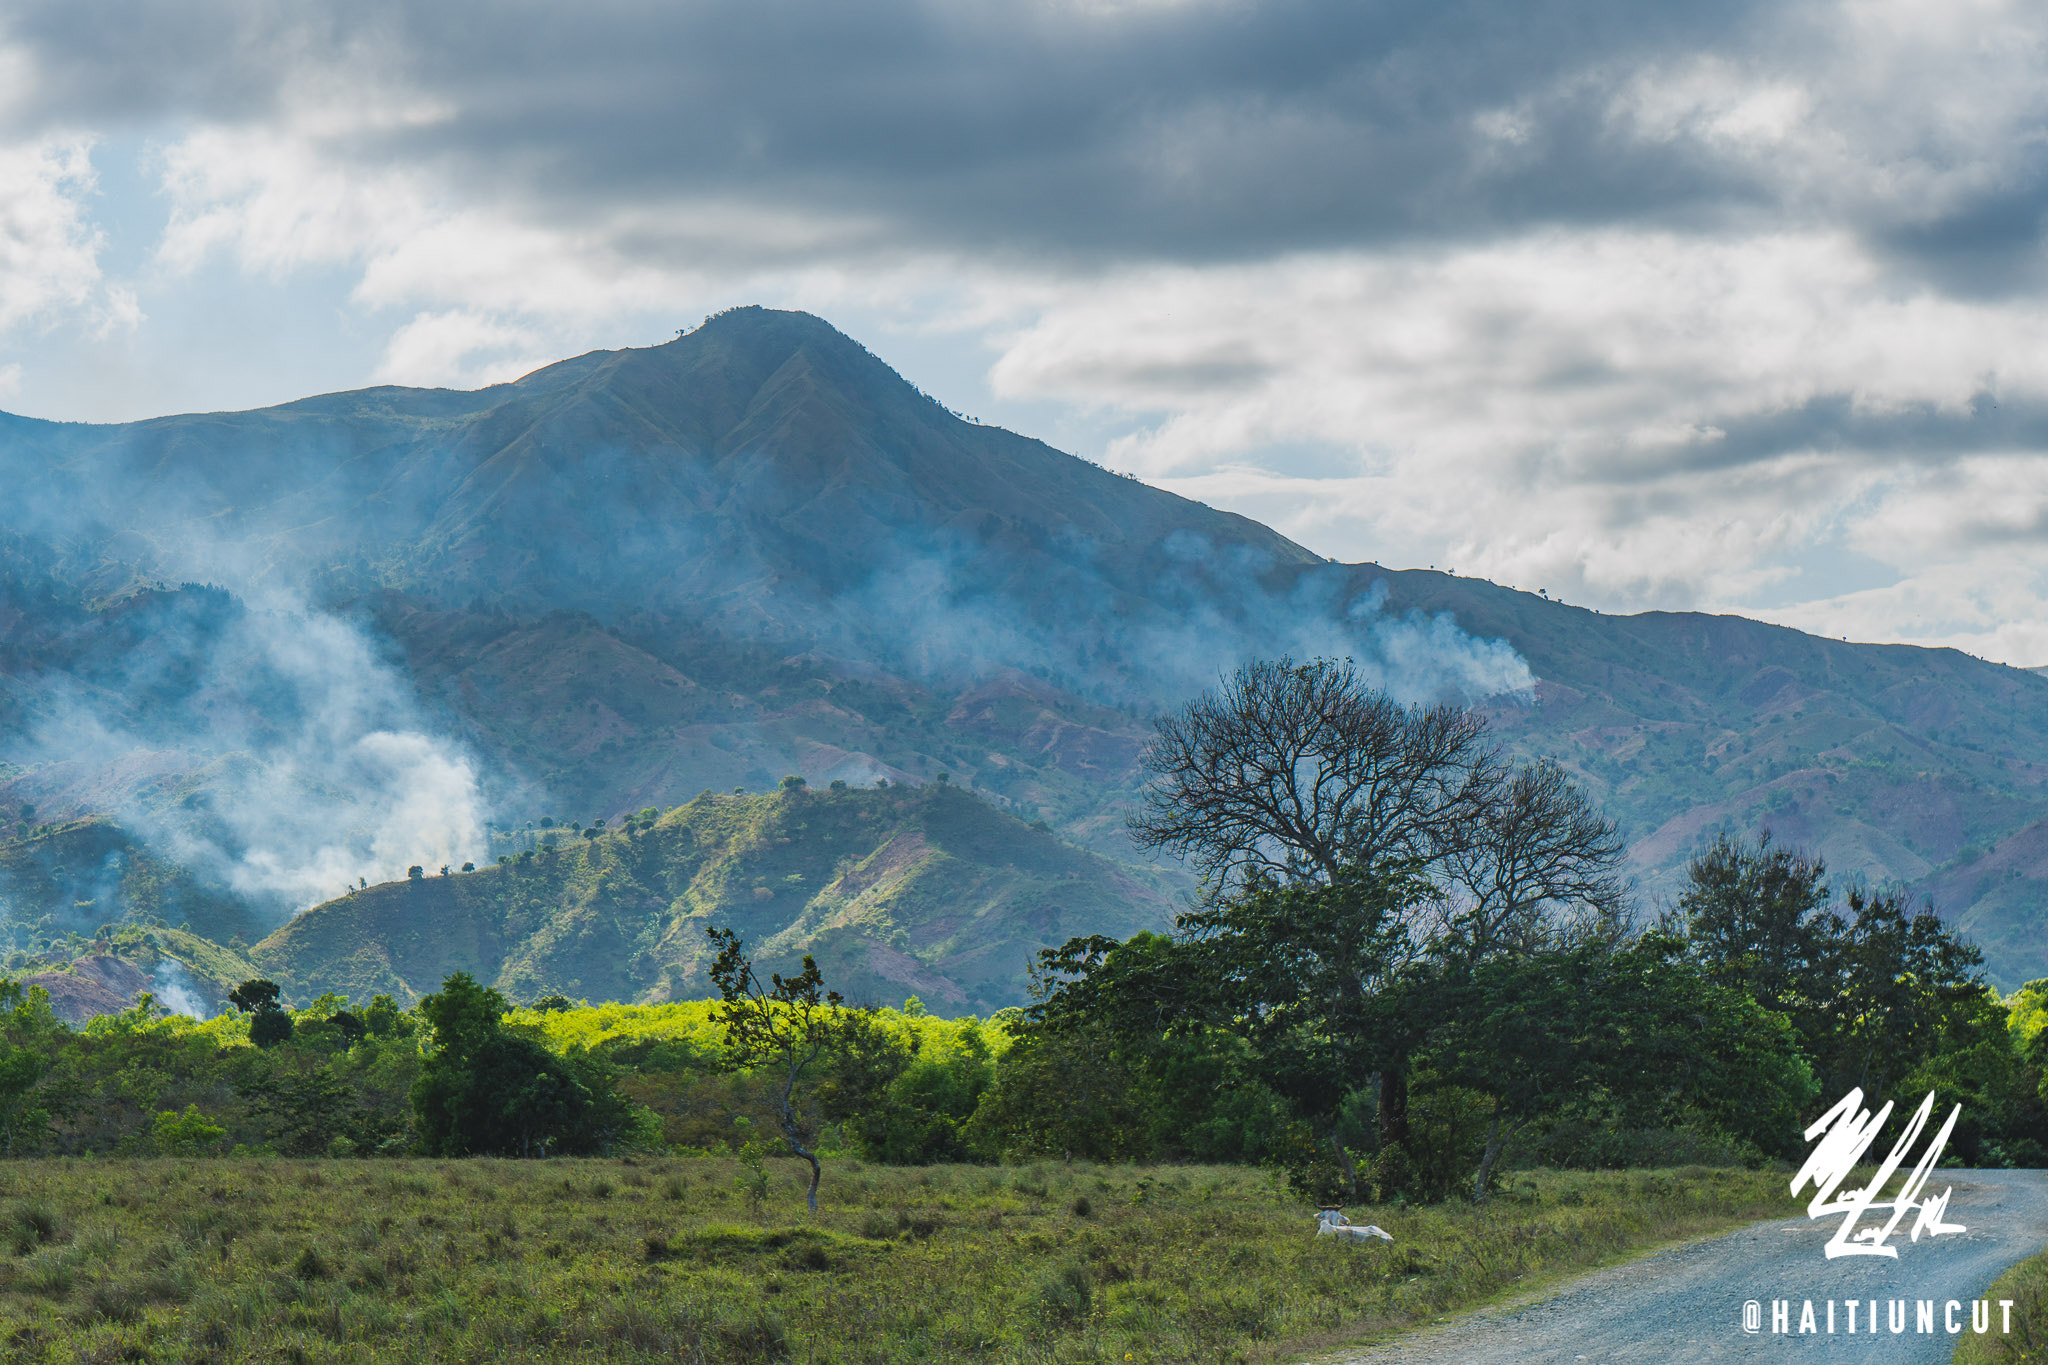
xmin=966 ymin=229 xmax=2048 ymax=624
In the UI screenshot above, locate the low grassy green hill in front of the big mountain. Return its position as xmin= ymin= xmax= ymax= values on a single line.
xmin=250 ymin=784 xmax=1169 ymax=1013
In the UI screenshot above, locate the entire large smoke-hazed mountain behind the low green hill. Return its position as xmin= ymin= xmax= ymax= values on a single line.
xmin=0 ymin=309 xmax=2048 ymax=1001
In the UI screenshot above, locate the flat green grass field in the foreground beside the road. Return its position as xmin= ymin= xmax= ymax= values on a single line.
xmin=0 ymin=1158 xmax=1784 ymax=1363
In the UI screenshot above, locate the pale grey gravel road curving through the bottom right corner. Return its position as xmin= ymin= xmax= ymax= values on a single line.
xmin=1331 ymin=1171 xmax=2048 ymax=1365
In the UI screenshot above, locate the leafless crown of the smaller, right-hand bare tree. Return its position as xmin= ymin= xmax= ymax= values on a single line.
xmin=1438 ymin=759 xmax=1628 ymax=964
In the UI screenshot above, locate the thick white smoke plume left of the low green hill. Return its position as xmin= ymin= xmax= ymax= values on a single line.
xmin=12 ymin=596 xmax=485 ymax=913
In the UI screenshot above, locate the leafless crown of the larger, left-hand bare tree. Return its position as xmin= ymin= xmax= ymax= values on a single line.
xmin=1130 ymin=659 xmax=1503 ymax=894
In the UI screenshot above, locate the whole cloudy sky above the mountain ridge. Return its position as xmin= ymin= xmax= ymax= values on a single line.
xmin=0 ymin=0 xmax=2048 ymax=667
